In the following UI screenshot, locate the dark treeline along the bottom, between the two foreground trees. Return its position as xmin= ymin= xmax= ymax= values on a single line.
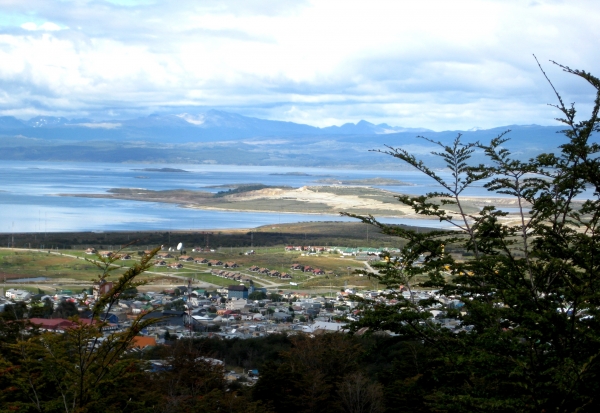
xmin=144 ymin=333 xmax=432 ymax=413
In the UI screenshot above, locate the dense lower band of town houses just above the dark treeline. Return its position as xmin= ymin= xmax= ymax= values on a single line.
xmin=0 ymin=280 xmax=478 ymax=347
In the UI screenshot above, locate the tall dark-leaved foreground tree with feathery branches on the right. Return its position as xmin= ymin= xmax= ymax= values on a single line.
xmin=344 ymin=65 xmax=600 ymax=412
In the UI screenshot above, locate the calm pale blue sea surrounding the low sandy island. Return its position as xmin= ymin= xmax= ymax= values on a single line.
xmin=0 ymin=161 xmax=502 ymax=233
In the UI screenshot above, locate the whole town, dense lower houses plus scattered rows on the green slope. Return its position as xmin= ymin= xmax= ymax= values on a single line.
xmin=0 ymin=246 xmax=469 ymax=366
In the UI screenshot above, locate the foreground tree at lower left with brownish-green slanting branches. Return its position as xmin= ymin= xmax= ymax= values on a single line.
xmin=0 ymin=248 xmax=159 ymax=412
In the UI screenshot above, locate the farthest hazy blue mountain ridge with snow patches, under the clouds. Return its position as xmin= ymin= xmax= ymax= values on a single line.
xmin=0 ymin=110 xmax=429 ymax=143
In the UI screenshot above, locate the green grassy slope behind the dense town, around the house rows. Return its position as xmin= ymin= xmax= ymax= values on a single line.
xmin=0 ymin=247 xmax=380 ymax=292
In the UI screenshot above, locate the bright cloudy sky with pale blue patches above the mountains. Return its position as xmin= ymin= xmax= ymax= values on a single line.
xmin=0 ymin=0 xmax=600 ymax=130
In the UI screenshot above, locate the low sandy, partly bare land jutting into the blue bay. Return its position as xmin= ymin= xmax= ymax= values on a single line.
xmin=59 ymin=184 xmax=532 ymax=224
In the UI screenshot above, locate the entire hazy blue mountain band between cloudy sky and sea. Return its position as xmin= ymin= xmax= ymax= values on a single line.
xmin=0 ymin=110 xmax=565 ymax=168
